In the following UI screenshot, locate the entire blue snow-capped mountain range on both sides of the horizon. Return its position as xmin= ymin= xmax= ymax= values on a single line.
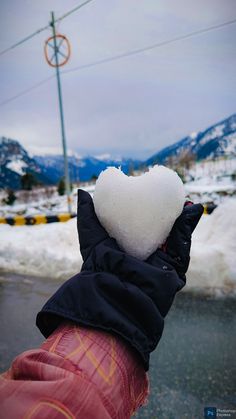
xmin=0 ymin=114 xmax=236 ymax=189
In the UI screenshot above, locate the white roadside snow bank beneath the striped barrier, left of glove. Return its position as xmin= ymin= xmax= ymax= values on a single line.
xmin=0 ymin=219 xmax=82 ymax=279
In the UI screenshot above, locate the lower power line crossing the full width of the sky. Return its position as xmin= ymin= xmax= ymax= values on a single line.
xmin=0 ymin=17 xmax=236 ymax=107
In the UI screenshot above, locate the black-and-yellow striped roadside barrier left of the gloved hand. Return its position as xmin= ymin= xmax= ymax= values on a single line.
xmin=0 ymin=213 xmax=76 ymax=226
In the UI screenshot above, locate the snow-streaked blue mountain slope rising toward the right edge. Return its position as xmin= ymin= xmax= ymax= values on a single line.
xmin=146 ymin=114 xmax=236 ymax=166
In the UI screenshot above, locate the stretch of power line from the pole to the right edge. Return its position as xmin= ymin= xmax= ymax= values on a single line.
xmin=62 ymin=19 xmax=236 ymax=74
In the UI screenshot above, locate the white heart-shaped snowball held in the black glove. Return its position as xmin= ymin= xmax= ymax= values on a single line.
xmin=93 ymin=165 xmax=185 ymax=260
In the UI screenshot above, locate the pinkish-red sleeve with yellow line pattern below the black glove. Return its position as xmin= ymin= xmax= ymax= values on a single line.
xmin=0 ymin=323 xmax=148 ymax=419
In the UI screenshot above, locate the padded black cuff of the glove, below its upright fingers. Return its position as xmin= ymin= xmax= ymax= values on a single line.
xmin=37 ymin=239 xmax=183 ymax=370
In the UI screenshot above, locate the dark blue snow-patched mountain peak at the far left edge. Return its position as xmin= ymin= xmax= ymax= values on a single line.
xmin=0 ymin=137 xmax=52 ymax=189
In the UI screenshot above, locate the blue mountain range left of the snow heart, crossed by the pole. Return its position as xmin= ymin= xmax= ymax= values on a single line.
xmin=0 ymin=137 xmax=140 ymax=189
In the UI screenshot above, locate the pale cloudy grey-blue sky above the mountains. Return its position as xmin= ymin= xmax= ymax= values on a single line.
xmin=0 ymin=0 xmax=236 ymax=159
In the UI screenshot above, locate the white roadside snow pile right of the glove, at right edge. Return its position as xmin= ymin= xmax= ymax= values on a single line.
xmin=185 ymin=199 xmax=236 ymax=294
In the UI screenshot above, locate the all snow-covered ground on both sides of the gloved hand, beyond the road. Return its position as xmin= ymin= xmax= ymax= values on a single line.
xmin=0 ymin=159 xmax=236 ymax=295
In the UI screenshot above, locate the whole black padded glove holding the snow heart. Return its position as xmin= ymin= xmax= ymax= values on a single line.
xmin=36 ymin=190 xmax=203 ymax=370
